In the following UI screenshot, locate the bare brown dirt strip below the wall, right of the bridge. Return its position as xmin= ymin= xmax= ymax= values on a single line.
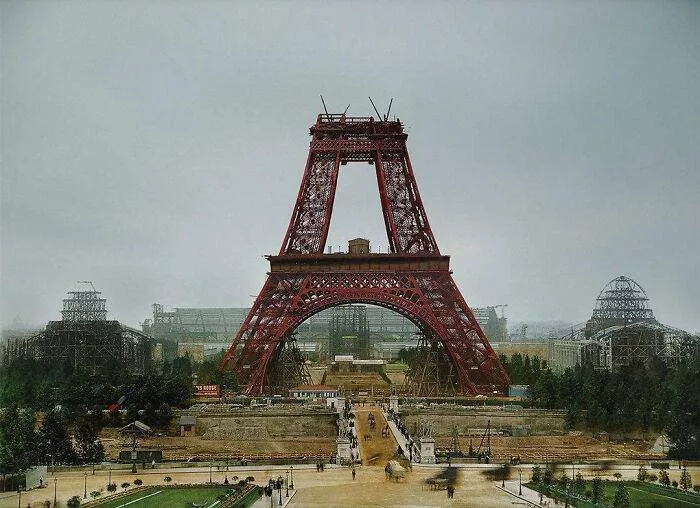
xmin=436 ymin=435 xmax=663 ymax=462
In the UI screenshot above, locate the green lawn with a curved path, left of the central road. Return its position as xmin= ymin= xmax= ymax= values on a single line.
xmin=93 ymin=487 xmax=252 ymax=508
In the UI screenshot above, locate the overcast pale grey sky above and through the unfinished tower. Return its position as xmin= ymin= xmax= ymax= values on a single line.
xmin=0 ymin=0 xmax=700 ymax=330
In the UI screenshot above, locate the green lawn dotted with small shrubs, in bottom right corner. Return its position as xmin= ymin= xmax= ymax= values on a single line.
xmin=528 ymin=481 xmax=700 ymax=508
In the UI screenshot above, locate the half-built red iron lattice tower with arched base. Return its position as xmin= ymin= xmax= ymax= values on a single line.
xmin=220 ymin=114 xmax=509 ymax=395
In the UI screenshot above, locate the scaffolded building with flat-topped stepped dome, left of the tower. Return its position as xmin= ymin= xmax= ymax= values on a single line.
xmin=4 ymin=283 xmax=152 ymax=373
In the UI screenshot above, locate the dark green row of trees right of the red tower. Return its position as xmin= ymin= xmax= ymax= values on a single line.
xmin=501 ymin=354 xmax=700 ymax=459
